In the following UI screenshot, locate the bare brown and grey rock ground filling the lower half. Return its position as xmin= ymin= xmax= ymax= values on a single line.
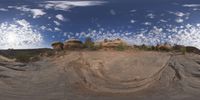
xmin=0 ymin=51 xmax=200 ymax=100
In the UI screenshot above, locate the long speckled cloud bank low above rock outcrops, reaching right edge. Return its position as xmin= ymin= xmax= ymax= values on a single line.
xmin=83 ymin=24 xmax=200 ymax=49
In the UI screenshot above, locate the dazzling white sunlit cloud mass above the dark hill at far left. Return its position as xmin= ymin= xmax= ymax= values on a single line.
xmin=0 ymin=20 xmax=43 ymax=49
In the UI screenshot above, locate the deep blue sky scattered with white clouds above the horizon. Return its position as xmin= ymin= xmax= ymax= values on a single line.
xmin=0 ymin=0 xmax=200 ymax=49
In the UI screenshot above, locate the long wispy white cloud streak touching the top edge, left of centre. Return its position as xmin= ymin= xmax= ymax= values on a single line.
xmin=40 ymin=1 xmax=105 ymax=11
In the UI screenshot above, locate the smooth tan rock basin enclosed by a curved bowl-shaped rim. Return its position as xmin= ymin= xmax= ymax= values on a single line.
xmin=63 ymin=52 xmax=170 ymax=93
